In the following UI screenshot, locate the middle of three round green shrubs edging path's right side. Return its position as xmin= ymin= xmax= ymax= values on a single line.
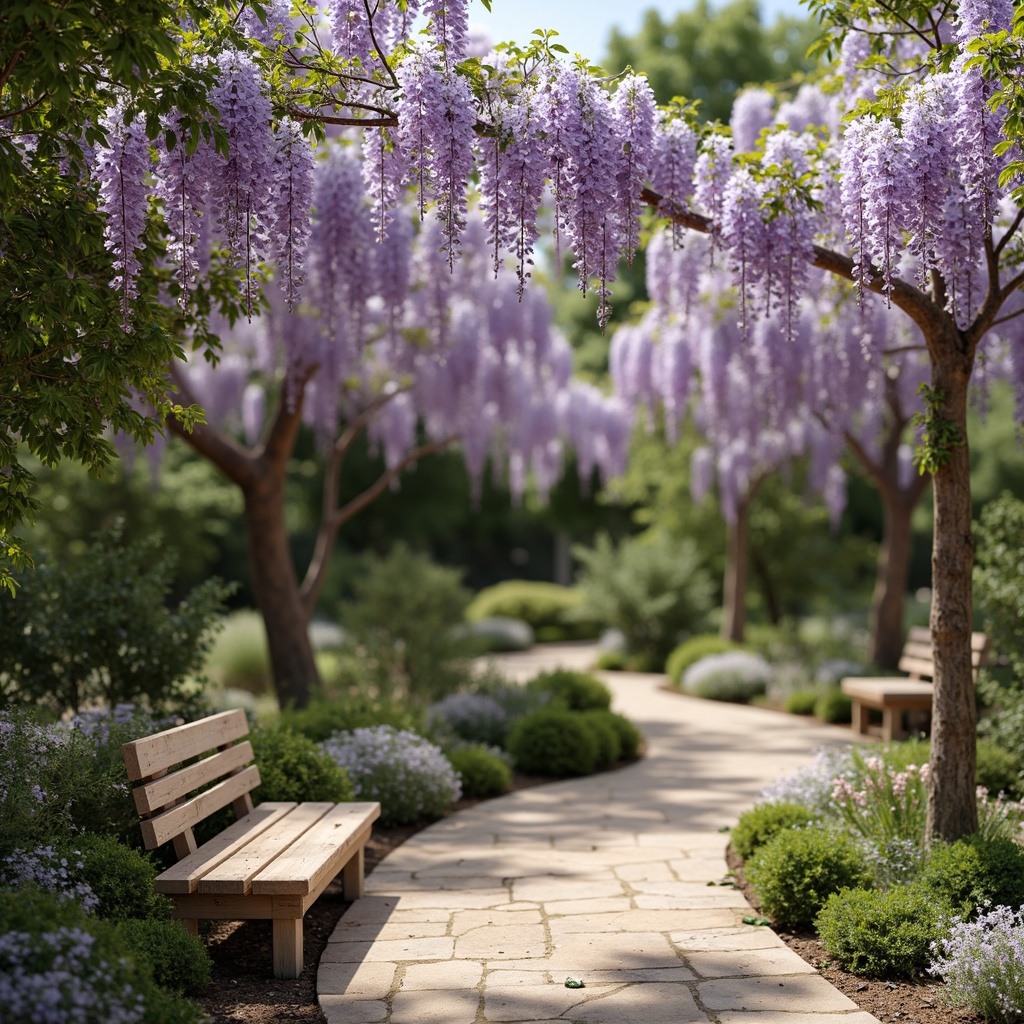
xmin=746 ymin=827 xmax=871 ymax=928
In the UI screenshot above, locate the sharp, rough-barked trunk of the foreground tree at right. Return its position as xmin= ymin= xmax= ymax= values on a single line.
xmin=927 ymin=348 xmax=978 ymax=842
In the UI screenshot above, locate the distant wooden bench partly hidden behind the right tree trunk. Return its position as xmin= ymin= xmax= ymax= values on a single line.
xmin=840 ymin=626 xmax=988 ymax=740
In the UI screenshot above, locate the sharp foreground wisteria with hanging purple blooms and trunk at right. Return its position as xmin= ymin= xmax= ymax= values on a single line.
xmin=44 ymin=0 xmax=1024 ymax=840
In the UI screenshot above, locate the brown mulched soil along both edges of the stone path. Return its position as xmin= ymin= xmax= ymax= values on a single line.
xmin=199 ymin=776 xmax=982 ymax=1024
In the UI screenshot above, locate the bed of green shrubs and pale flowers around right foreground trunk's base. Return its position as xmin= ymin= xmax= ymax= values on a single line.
xmin=732 ymin=739 xmax=1024 ymax=1020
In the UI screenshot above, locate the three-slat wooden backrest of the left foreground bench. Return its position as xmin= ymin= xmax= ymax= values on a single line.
xmin=121 ymin=710 xmax=259 ymax=858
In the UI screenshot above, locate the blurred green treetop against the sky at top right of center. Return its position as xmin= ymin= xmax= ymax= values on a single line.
xmin=604 ymin=0 xmax=815 ymax=122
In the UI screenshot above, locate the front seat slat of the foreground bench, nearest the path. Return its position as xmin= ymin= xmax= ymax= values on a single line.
xmin=252 ymin=803 xmax=380 ymax=896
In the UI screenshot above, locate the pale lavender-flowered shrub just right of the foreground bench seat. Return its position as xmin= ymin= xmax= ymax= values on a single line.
xmin=321 ymin=725 xmax=462 ymax=825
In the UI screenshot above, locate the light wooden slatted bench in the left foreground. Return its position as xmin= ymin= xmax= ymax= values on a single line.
xmin=122 ymin=711 xmax=380 ymax=978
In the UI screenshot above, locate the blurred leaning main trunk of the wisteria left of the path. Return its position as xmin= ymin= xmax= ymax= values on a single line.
xmin=244 ymin=464 xmax=319 ymax=708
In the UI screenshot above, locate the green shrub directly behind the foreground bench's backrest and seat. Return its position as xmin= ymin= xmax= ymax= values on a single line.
xmin=251 ymin=726 xmax=355 ymax=804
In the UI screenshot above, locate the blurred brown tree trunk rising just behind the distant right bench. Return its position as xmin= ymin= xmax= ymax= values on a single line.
xmin=871 ymin=486 xmax=916 ymax=669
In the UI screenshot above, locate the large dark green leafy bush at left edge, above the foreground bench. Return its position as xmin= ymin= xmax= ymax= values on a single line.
xmin=0 ymin=526 xmax=230 ymax=714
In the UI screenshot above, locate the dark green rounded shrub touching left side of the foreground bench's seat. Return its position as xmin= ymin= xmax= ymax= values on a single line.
xmin=66 ymin=835 xmax=172 ymax=928
